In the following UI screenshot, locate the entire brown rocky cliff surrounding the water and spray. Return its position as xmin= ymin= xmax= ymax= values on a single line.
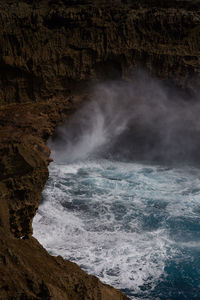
xmin=0 ymin=0 xmax=200 ymax=300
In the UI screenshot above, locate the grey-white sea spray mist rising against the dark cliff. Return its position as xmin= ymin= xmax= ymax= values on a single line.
xmin=49 ymin=72 xmax=200 ymax=164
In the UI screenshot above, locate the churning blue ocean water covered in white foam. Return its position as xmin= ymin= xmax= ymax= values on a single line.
xmin=33 ymin=159 xmax=200 ymax=300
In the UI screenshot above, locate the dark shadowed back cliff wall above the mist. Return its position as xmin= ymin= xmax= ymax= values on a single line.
xmin=0 ymin=0 xmax=200 ymax=104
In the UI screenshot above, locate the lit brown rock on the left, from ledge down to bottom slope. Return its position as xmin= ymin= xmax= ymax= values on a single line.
xmin=0 ymin=97 xmax=128 ymax=300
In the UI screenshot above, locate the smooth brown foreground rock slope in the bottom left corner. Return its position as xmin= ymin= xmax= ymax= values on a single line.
xmin=0 ymin=225 xmax=128 ymax=300
